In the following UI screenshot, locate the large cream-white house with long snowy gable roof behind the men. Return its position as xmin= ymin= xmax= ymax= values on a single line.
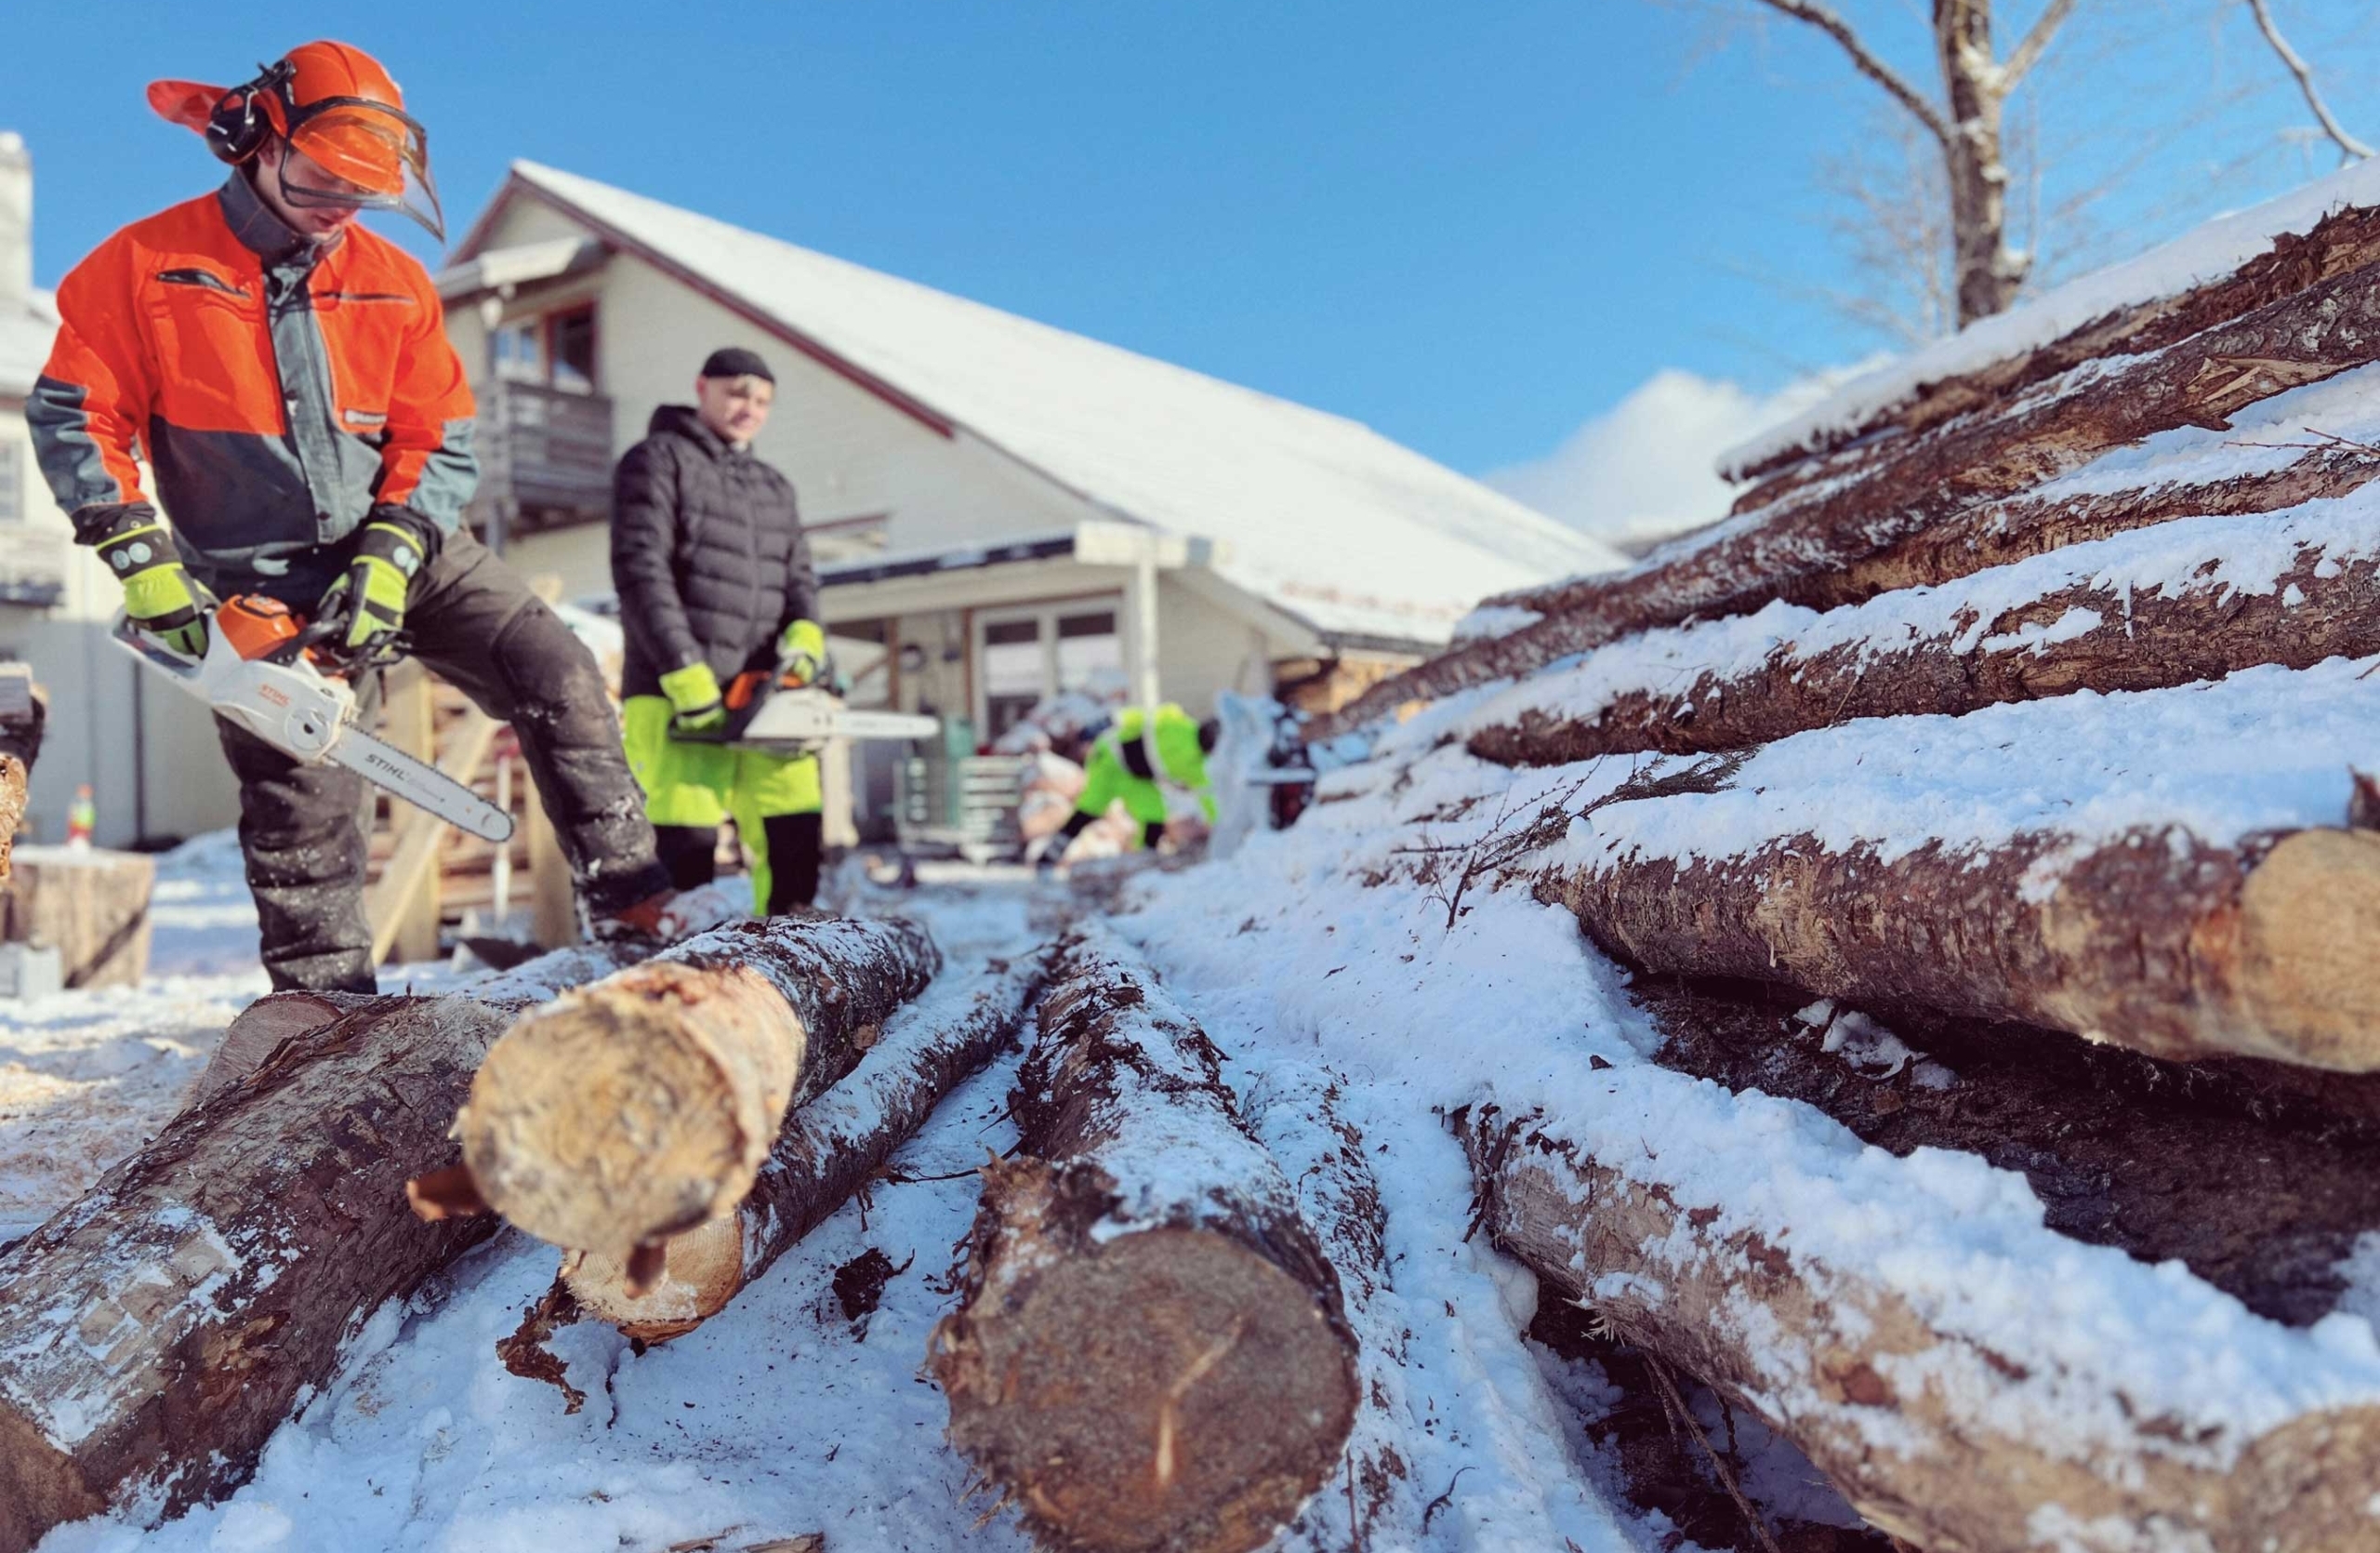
xmin=441 ymin=162 xmax=1620 ymax=762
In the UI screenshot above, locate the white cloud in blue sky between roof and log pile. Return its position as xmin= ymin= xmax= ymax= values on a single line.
xmin=1485 ymin=366 xmax=1842 ymax=551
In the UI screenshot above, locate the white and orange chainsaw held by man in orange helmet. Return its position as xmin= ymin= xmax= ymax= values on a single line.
xmin=114 ymin=593 xmax=511 ymax=841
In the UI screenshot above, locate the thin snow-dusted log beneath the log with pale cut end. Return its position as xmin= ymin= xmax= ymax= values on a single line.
xmin=562 ymin=953 xmax=1047 ymax=1344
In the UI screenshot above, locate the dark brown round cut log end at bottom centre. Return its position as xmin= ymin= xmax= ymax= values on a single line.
xmin=935 ymin=1229 xmax=1356 ymax=1553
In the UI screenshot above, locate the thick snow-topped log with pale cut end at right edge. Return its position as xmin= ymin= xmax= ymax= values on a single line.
xmin=1494 ymin=659 xmax=2380 ymax=1072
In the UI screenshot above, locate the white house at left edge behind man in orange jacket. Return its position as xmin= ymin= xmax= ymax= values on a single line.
xmin=0 ymin=131 xmax=238 ymax=845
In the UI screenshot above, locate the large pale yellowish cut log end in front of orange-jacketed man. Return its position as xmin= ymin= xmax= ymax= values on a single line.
xmin=455 ymin=962 xmax=804 ymax=1260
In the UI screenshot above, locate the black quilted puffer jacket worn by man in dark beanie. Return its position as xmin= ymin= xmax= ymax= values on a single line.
xmin=612 ymin=405 xmax=819 ymax=696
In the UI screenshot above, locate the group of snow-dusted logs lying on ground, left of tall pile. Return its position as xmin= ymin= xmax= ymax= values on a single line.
xmin=0 ymin=920 xmax=1378 ymax=1553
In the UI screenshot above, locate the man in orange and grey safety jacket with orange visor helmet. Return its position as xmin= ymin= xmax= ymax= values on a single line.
xmin=26 ymin=43 xmax=668 ymax=991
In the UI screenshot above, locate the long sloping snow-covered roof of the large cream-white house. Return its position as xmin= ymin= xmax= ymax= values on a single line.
xmin=459 ymin=162 xmax=1623 ymax=644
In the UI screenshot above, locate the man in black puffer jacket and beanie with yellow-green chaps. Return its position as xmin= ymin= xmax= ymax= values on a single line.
xmin=612 ymin=348 xmax=826 ymax=917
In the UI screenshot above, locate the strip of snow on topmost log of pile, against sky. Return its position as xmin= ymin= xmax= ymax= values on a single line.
xmin=1718 ymin=160 xmax=2380 ymax=479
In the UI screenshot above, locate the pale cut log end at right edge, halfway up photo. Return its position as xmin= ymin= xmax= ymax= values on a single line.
xmin=2237 ymin=829 xmax=2380 ymax=1072
